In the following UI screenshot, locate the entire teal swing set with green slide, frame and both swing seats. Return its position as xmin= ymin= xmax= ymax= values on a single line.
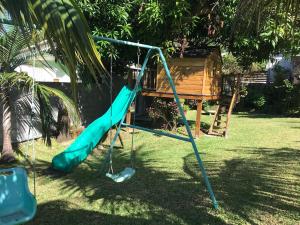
xmin=0 ymin=36 xmax=218 ymax=225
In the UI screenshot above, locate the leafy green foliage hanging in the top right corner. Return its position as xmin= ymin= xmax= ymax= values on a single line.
xmin=229 ymin=0 xmax=300 ymax=67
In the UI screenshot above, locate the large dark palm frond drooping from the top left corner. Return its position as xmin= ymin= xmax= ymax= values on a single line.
xmin=0 ymin=0 xmax=108 ymax=93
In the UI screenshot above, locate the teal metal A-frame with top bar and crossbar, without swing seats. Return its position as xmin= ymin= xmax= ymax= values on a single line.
xmin=93 ymin=36 xmax=218 ymax=209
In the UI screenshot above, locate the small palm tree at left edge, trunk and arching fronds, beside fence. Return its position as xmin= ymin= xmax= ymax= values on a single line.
xmin=0 ymin=27 xmax=79 ymax=161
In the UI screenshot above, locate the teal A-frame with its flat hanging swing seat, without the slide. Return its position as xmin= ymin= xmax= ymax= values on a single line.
xmin=94 ymin=36 xmax=218 ymax=209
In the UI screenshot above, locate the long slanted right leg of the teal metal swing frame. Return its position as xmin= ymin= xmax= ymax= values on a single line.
xmin=158 ymin=49 xmax=218 ymax=209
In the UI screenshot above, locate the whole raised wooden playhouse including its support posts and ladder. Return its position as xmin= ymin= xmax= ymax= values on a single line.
xmin=127 ymin=47 xmax=238 ymax=137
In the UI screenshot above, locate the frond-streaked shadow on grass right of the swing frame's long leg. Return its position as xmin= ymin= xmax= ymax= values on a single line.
xmin=184 ymin=148 xmax=300 ymax=224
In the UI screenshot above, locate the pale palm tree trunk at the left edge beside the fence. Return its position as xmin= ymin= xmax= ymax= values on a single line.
xmin=1 ymin=88 xmax=15 ymax=162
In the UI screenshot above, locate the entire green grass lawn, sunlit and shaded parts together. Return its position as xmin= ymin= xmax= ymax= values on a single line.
xmin=0 ymin=113 xmax=300 ymax=225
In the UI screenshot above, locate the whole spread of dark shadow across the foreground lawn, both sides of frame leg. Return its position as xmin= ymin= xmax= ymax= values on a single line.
xmin=2 ymin=140 xmax=300 ymax=225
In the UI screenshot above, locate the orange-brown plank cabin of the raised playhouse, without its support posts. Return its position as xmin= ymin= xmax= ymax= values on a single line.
xmin=143 ymin=49 xmax=222 ymax=99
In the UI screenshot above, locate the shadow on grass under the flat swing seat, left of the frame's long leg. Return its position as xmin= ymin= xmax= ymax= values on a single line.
xmin=31 ymin=146 xmax=227 ymax=225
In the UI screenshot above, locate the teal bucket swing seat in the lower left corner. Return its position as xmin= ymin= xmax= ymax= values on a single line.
xmin=0 ymin=168 xmax=37 ymax=225
